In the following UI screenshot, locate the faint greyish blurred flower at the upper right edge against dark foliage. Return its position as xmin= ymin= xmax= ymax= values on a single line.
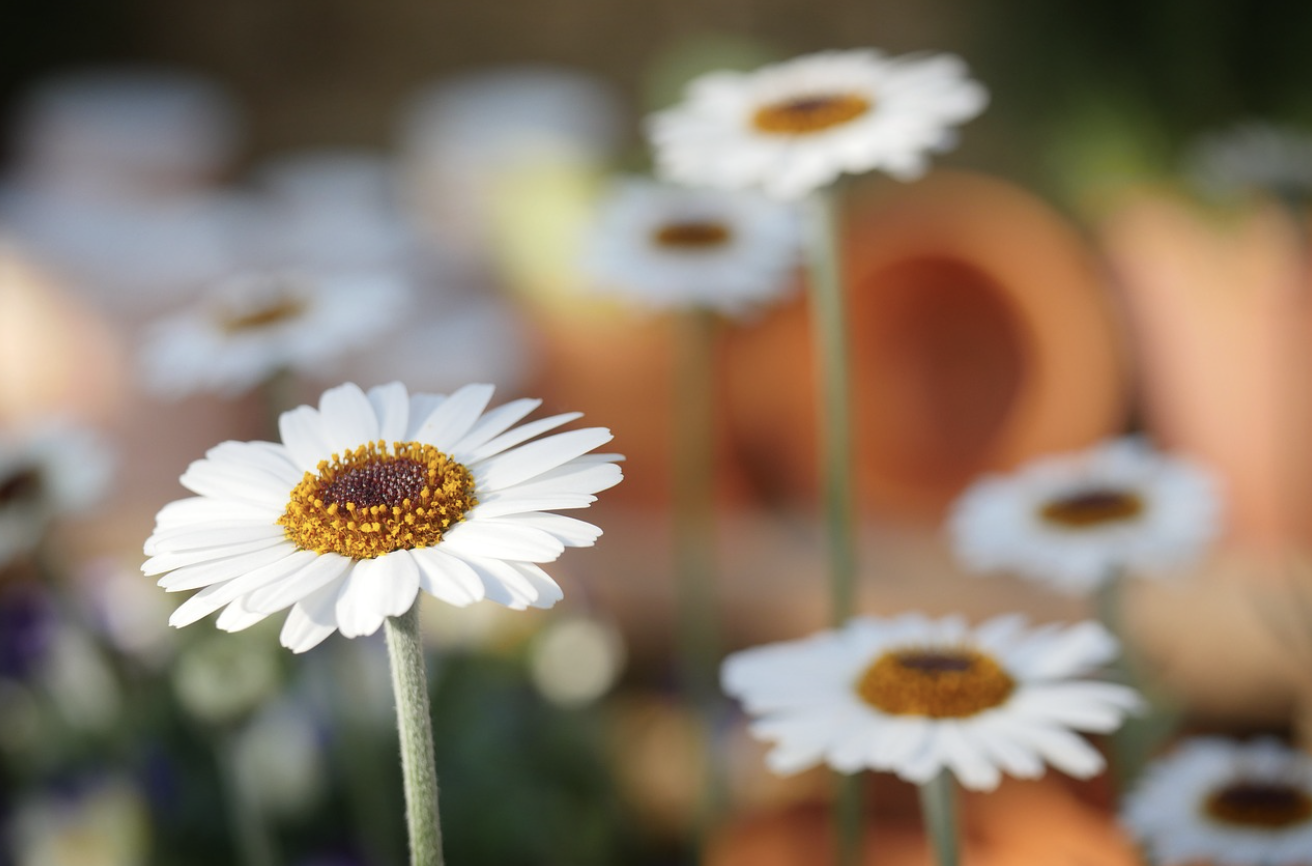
xmin=1186 ymin=122 xmax=1312 ymax=201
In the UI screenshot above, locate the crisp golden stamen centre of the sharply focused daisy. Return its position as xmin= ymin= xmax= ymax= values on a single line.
xmin=278 ymin=441 xmax=478 ymax=559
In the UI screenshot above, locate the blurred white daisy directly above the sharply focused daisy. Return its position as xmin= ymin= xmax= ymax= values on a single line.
xmin=142 ymin=272 xmax=409 ymax=398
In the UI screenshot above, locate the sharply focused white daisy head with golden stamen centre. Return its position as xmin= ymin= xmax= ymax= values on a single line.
xmin=142 ymin=383 xmax=622 ymax=652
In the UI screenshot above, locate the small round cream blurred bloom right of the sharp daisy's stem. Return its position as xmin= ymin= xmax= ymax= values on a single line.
xmin=529 ymin=617 xmax=625 ymax=706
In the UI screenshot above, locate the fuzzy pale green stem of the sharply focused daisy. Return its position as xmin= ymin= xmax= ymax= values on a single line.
xmin=384 ymin=600 xmax=442 ymax=866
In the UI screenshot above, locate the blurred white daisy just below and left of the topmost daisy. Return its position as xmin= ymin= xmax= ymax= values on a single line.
xmin=584 ymin=177 xmax=802 ymax=314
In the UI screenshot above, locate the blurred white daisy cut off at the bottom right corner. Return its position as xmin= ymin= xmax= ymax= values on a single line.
xmin=1122 ymin=737 xmax=1312 ymax=866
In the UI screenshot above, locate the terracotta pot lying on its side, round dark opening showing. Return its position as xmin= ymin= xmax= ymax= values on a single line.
xmin=728 ymin=172 xmax=1127 ymax=520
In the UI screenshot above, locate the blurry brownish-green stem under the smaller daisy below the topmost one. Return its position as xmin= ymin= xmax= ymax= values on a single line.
xmin=673 ymin=310 xmax=726 ymax=836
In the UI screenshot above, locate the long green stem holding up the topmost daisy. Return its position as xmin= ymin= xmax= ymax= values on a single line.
xmin=806 ymin=192 xmax=863 ymax=866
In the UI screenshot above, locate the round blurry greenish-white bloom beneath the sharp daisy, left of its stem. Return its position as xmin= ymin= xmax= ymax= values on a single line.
xmin=172 ymin=636 xmax=281 ymax=724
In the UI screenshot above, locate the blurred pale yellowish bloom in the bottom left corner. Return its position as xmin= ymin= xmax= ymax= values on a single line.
xmin=9 ymin=777 xmax=150 ymax=866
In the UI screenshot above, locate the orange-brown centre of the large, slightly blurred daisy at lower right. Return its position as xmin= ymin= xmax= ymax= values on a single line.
xmin=857 ymin=647 xmax=1015 ymax=719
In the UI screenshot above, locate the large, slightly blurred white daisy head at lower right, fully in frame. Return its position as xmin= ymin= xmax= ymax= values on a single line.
xmin=720 ymin=614 xmax=1140 ymax=790
